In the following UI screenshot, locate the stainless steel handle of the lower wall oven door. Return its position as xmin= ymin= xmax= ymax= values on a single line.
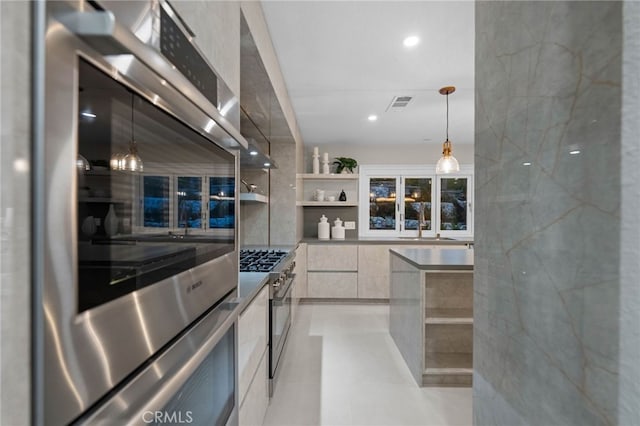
xmin=80 ymin=300 xmax=239 ymax=425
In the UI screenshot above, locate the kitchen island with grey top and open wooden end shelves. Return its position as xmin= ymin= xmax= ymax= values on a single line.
xmin=389 ymin=246 xmax=473 ymax=387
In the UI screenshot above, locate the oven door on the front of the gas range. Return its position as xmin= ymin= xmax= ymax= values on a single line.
xmin=269 ymin=279 xmax=293 ymax=378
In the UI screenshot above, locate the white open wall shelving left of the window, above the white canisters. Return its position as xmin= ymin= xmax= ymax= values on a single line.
xmin=297 ymin=173 xmax=358 ymax=207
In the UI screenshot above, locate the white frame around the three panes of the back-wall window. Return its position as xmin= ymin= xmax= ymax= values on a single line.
xmin=358 ymin=165 xmax=474 ymax=238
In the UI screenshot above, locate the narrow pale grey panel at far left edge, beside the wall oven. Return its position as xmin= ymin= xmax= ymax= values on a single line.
xmin=0 ymin=1 xmax=31 ymax=425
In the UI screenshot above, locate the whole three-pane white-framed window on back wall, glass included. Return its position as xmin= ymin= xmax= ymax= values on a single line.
xmin=359 ymin=165 xmax=473 ymax=238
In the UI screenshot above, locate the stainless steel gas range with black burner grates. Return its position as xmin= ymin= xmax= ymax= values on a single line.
xmin=240 ymin=249 xmax=296 ymax=395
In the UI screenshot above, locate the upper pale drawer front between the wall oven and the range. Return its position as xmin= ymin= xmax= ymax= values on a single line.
xmin=238 ymin=286 xmax=269 ymax=401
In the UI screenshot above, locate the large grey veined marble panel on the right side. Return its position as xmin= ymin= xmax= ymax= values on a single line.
xmin=474 ymin=1 xmax=623 ymax=425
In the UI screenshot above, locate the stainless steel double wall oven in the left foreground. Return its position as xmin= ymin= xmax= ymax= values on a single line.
xmin=35 ymin=0 xmax=246 ymax=425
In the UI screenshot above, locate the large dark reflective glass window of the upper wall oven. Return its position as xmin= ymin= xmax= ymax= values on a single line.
xmin=77 ymin=58 xmax=236 ymax=312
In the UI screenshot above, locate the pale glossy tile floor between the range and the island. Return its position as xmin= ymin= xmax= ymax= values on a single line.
xmin=264 ymin=304 xmax=472 ymax=426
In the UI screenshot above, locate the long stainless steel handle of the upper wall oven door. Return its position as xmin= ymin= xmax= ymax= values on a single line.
xmin=56 ymin=11 xmax=249 ymax=149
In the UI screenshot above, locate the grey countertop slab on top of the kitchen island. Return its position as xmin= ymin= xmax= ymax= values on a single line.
xmin=389 ymin=247 xmax=473 ymax=271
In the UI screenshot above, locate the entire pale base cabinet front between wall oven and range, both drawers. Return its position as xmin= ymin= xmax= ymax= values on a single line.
xmin=238 ymin=286 xmax=269 ymax=425
